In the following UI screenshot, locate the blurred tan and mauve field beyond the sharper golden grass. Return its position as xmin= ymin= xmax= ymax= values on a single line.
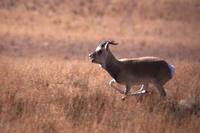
xmin=0 ymin=0 xmax=200 ymax=59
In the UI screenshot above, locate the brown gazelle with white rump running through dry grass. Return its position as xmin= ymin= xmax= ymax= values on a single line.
xmin=89 ymin=41 xmax=175 ymax=100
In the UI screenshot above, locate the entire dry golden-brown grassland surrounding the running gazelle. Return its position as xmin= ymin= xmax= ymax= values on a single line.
xmin=0 ymin=0 xmax=200 ymax=133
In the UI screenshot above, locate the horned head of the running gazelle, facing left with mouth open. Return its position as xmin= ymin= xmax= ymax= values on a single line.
xmin=89 ymin=41 xmax=117 ymax=66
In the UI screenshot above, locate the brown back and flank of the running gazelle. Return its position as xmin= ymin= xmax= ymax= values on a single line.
xmin=119 ymin=57 xmax=171 ymax=84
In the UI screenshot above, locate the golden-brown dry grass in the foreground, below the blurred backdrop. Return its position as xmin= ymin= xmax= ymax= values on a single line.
xmin=0 ymin=58 xmax=200 ymax=133
